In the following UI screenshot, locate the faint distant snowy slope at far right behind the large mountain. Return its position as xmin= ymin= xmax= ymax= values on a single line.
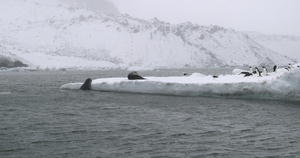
xmin=245 ymin=32 xmax=300 ymax=62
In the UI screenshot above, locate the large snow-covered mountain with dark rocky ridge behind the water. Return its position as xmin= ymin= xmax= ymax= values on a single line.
xmin=0 ymin=0 xmax=294 ymax=68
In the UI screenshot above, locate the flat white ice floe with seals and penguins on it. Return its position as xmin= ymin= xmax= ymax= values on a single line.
xmin=61 ymin=68 xmax=300 ymax=100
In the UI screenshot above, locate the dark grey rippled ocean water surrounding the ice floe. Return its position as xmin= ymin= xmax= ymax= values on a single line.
xmin=0 ymin=70 xmax=300 ymax=158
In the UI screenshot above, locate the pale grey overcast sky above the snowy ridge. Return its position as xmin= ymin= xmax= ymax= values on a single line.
xmin=113 ymin=0 xmax=300 ymax=36
